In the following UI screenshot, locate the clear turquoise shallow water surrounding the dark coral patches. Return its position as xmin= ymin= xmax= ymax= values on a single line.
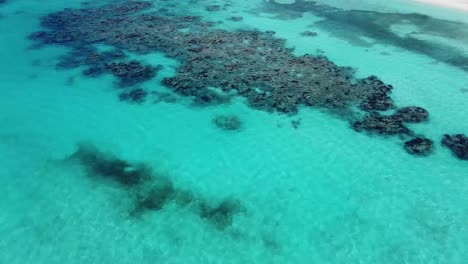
xmin=0 ymin=0 xmax=468 ymax=264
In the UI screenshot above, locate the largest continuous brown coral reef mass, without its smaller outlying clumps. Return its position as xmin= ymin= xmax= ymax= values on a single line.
xmin=28 ymin=2 xmax=389 ymax=112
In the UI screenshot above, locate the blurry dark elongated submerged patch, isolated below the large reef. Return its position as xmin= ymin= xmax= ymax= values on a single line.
xmin=69 ymin=144 xmax=244 ymax=230
